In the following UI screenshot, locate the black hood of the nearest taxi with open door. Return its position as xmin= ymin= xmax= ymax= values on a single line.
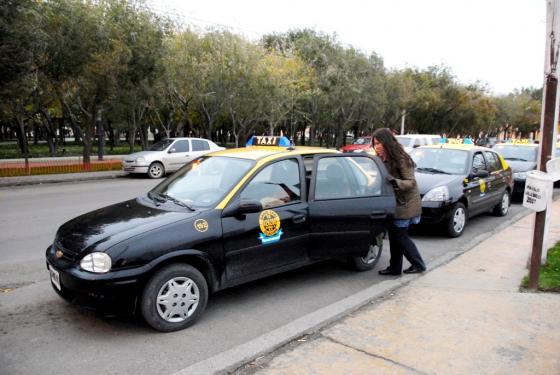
xmin=55 ymin=197 xmax=200 ymax=254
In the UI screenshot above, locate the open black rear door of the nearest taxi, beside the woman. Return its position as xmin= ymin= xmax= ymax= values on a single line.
xmin=309 ymin=153 xmax=396 ymax=259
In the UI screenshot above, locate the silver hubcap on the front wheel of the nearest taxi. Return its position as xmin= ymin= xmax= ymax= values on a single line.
xmin=156 ymin=277 xmax=200 ymax=323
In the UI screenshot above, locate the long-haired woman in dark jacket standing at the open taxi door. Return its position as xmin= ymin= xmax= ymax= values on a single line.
xmin=373 ymin=128 xmax=426 ymax=275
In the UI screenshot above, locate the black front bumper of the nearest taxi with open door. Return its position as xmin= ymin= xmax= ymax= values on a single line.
xmin=46 ymin=246 xmax=148 ymax=314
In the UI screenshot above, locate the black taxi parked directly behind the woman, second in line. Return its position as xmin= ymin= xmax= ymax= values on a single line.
xmin=410 ymin=144 xmax=513 ymax=237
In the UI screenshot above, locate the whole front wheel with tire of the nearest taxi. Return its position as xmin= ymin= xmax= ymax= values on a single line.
xmin=140 ymin=264 xmax=208 ymax=332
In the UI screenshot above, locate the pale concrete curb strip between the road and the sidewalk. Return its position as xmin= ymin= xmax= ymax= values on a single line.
xmin=173 ymin=209 xmax=533 ymax=375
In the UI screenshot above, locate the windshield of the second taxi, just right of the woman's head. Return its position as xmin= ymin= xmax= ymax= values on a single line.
xmin=410 ymin=148 xmax=469 ymax=174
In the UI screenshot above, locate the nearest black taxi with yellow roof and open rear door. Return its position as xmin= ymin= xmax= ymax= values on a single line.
xmin=46 ymin=137 xmax=395 ymax=331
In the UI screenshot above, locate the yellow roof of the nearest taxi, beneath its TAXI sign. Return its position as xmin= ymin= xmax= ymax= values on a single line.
xmin=208 ymin=146 xmax=339 ymax=160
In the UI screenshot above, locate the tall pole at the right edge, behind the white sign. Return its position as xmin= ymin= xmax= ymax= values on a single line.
xmin=528 ymin=0 xmax=560 ymax=291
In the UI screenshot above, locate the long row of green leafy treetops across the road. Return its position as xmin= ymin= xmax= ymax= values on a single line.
xmin=0 ymin=0 xmax=542 ymax=163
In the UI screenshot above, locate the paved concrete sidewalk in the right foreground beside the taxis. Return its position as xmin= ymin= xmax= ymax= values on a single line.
xmin=236 ymin=200 xmax=560 ymax=374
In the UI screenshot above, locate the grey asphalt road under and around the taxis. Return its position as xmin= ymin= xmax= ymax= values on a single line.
xmin=0 ymin=178 xmax=525 ymax=374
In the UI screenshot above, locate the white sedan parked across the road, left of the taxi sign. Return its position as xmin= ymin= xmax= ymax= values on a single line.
xmin=123 ymin=138 xmax=225 ymax=178
